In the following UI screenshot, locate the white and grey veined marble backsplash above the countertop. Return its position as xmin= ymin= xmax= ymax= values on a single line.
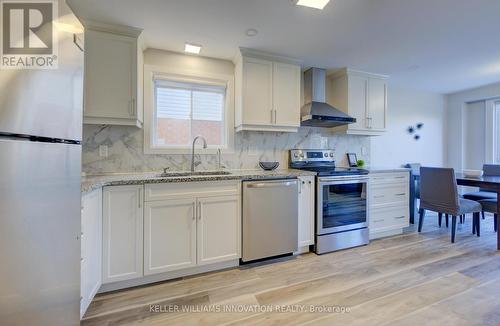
xmin=83 ymin=125 xmax=370 ymax=174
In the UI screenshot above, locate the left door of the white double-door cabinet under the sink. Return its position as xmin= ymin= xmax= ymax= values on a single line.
xmin=144 ymin=199 xmax=196 ymax=275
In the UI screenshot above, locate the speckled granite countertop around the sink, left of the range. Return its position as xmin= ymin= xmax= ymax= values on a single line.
xmin=81 ymin=169 xmax=316 ymax=193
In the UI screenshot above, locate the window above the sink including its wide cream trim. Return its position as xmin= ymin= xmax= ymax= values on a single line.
xmin=144 ymin=66 xmax=234 ymax=154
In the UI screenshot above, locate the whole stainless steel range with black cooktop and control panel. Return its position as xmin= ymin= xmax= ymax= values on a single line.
xmin=290 ymin=150 xmax=369 ymax=254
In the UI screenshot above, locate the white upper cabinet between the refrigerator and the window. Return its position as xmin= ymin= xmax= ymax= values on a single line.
xmin=84 ymin=22 xmax=143 ymax=127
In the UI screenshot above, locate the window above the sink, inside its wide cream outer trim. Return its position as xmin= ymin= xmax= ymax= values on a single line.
xmin=151 ymin=79 xmax=227 ymax=149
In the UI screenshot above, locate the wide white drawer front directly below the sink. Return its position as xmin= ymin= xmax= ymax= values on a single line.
xmin=145 ymin=181 xmax=241 ymax=202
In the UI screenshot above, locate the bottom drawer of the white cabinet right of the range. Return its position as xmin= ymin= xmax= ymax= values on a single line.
xmin=369 ymin=206 xmax=410 ymax=231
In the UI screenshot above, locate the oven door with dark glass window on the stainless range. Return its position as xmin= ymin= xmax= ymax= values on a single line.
xmin=316 ymin=176 xmax=368 ymax=235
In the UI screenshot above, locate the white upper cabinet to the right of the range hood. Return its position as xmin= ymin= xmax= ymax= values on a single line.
xmin=327 ymin=69 xmax=387 ymax=136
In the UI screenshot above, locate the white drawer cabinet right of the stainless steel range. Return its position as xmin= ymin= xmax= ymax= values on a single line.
xmin=369 ymin=172 xmax=410 ymax=239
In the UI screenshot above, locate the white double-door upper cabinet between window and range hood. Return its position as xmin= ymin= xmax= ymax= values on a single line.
xmin=235 ymin=49 xmax=301 ymax=132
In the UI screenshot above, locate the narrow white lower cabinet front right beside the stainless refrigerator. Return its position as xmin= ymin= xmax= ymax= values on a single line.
xmin=80 ymin=189 xmax=102 ymax=318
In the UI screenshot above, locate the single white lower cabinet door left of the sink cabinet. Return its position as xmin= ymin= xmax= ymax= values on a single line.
xmin=102 ymin=185 xmax=144 ymax=283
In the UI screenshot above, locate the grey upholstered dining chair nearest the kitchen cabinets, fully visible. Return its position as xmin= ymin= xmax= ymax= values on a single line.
xmin=418 ymin=167 xmax=482 ymax=243
